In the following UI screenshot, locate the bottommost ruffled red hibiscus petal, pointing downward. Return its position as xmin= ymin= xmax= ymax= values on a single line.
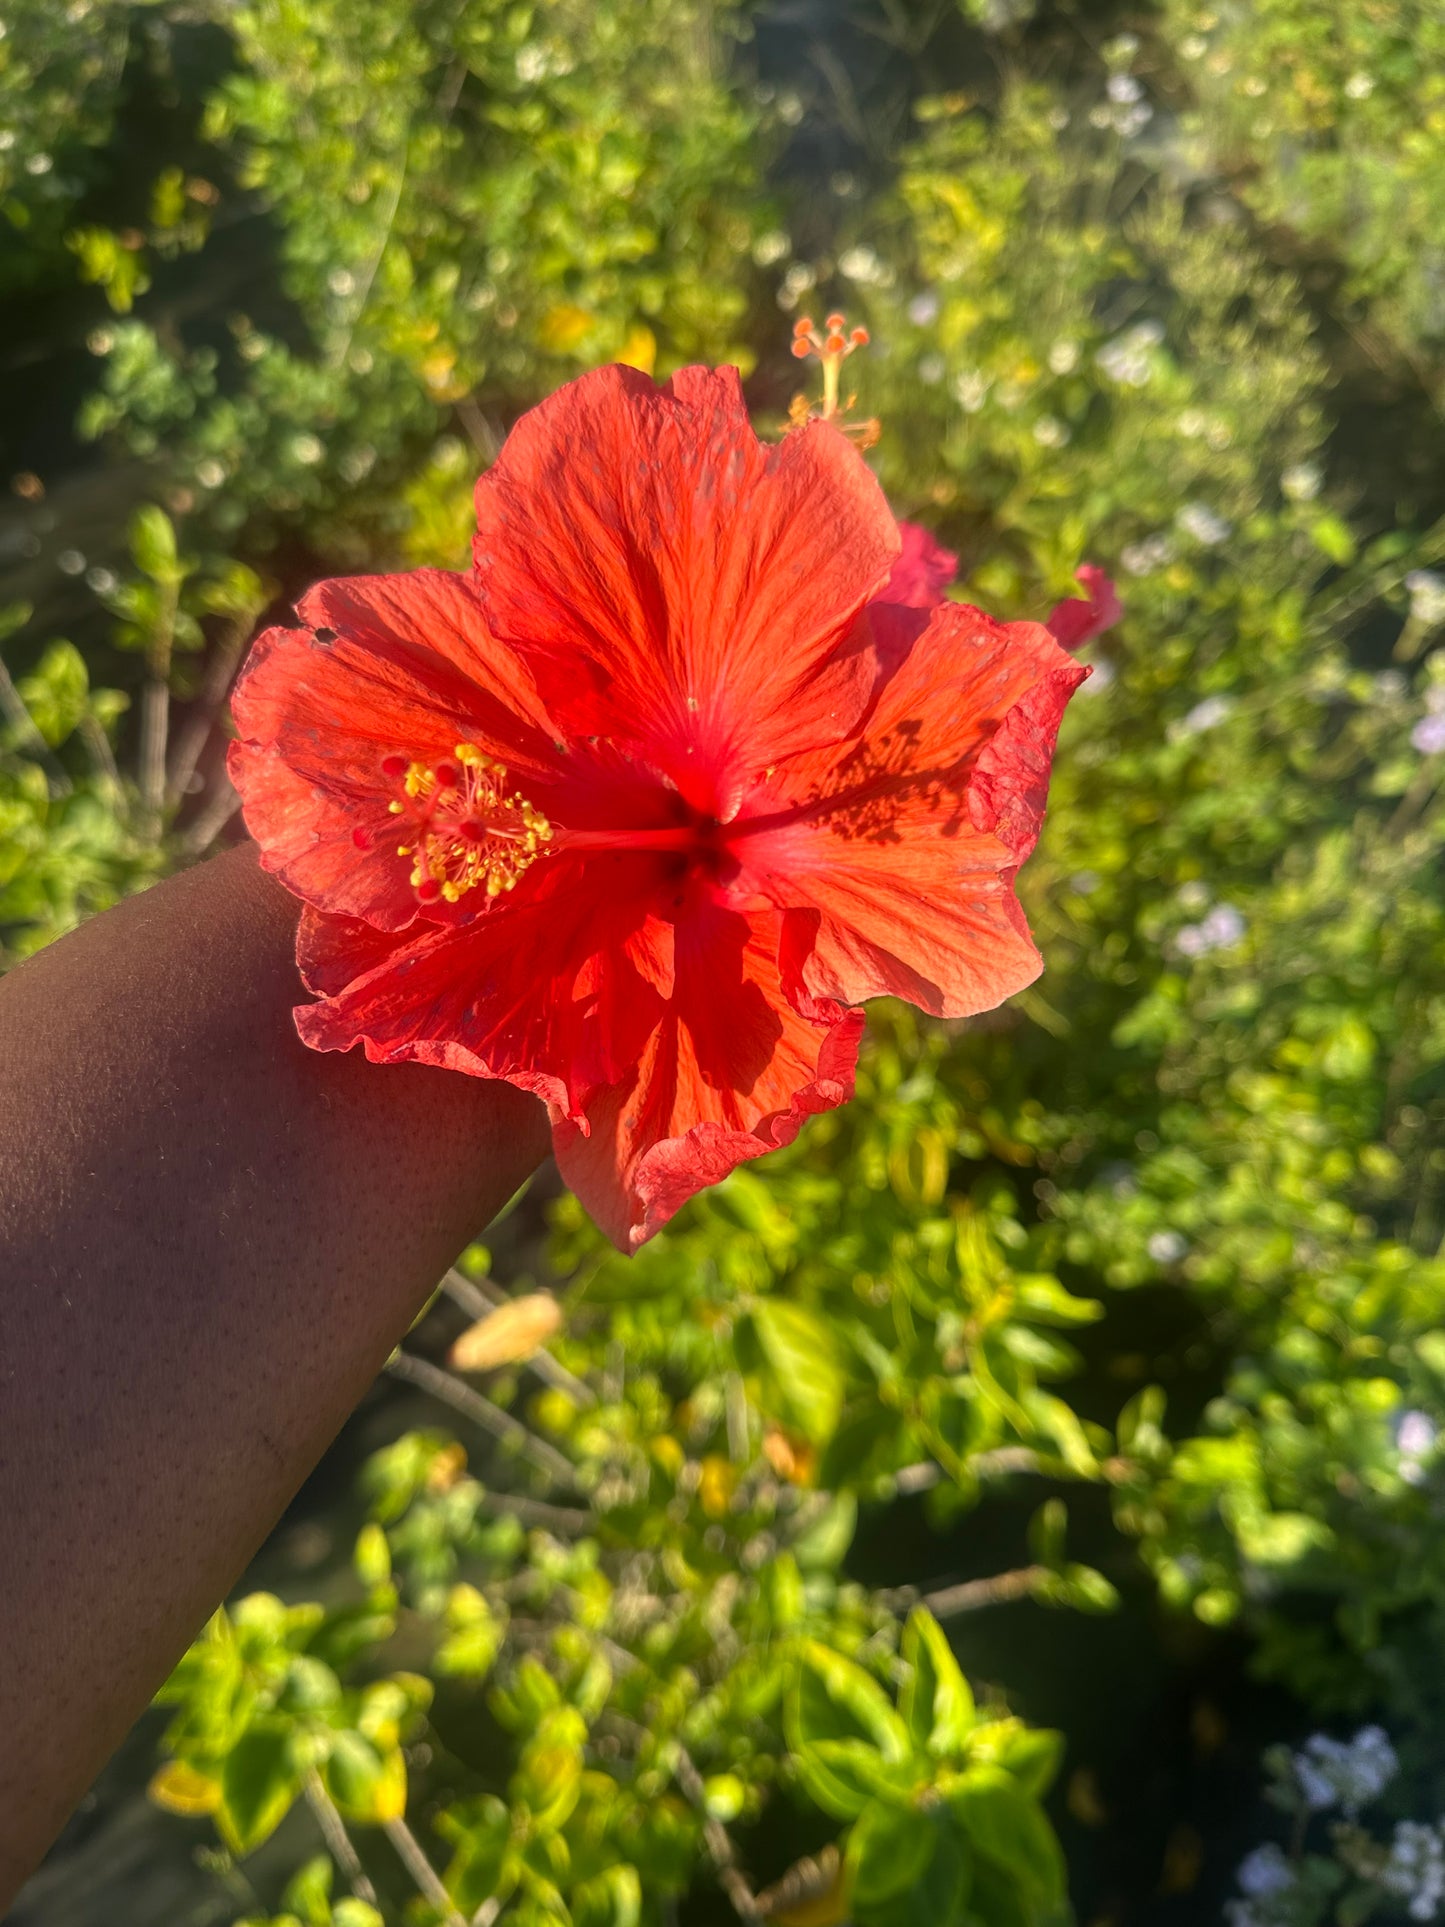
xmin=553 ymin=904 xmax=863 ymax=1251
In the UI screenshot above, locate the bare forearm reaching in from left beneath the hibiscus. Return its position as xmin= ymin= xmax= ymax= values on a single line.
xmin=0 ymin=848 xmax=547 ymax=1912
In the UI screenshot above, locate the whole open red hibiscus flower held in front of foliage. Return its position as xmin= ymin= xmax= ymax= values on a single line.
xmin=231 ymin=368 xmax=1085 ymax=1249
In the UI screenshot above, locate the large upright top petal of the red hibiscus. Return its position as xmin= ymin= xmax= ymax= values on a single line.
xmin=474 ymin=368 xmax=900 ymax=819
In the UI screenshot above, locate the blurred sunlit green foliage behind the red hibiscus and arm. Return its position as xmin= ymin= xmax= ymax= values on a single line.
xmin=0 ymin=0 xmax=1445 ymax=1927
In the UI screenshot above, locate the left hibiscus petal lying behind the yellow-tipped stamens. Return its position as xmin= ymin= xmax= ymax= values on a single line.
xmin=229 ymin=568 xmax=557 ymax=929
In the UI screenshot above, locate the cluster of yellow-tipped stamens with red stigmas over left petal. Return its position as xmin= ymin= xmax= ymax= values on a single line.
xmin=381 ymin=742 xmax=553 ymax=904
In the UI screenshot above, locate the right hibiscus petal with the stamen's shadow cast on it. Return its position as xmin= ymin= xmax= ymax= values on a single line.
xmin=744 ymin=603 xmax=1087 ymax=1017
